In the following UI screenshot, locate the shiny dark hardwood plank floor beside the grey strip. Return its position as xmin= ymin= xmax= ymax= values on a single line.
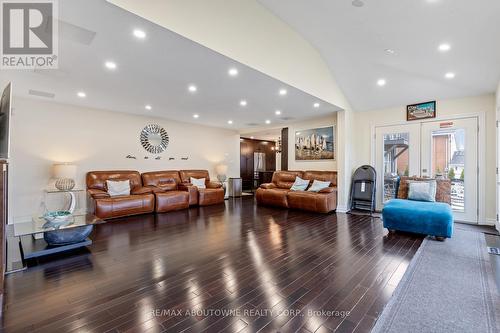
xmin=2 ymin=197 xmax=422 ymax=333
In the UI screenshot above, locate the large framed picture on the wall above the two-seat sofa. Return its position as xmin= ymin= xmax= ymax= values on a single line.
xmin=295 ymin=126 xmax=335 ymax=161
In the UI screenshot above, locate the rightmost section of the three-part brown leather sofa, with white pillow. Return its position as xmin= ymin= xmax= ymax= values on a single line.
xmin=179 ymin=170 xmax=224 ymax=206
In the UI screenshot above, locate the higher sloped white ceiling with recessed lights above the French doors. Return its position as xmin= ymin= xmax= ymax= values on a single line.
xmin=258 ymin=0 xmax=500 ymax=111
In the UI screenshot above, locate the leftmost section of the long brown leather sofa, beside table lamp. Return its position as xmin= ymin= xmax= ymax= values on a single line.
xmin=87 ymin=171 xmax=155 ymax=219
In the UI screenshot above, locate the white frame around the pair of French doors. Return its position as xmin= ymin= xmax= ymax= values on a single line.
xmin=370 ymin=111 xmax=486 ymax=225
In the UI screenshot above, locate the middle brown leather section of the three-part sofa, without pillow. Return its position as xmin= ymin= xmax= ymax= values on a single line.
xmin=142 ymin=171 xmax=189 ymax=213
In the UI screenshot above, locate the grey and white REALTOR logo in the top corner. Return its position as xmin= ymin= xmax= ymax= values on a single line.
xmin=0 ymin=0 xmax=58 ymax=69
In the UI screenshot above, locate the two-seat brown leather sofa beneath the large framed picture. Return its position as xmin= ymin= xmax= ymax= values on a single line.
xmin=255 ymin=171 xmax=337 ymax=213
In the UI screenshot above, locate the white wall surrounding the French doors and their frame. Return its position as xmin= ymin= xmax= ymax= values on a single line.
xmin=351 ymin=94 xmax=496 ymax=223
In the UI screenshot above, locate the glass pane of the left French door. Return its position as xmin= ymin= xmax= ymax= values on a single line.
xmin=383 ymin=132 xmax=410 ymax=203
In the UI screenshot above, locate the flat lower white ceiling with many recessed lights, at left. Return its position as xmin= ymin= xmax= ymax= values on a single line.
xmin=0 ymin=0 xmax=339 ymax=130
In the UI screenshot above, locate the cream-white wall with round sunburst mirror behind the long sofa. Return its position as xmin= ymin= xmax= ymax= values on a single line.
xmin=9 ymin=97 xmax=240 ymax=223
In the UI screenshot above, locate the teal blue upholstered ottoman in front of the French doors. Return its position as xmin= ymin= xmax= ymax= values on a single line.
xmin=382 ymin=199 xmax=453 ymax=238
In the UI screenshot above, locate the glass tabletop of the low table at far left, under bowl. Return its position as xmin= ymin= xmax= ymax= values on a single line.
xmin=14 ymin=214 xmax=105 ymax=237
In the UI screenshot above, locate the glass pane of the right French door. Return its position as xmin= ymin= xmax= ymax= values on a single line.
xmin=432 ymin=128 xmax=465 ymax=212
